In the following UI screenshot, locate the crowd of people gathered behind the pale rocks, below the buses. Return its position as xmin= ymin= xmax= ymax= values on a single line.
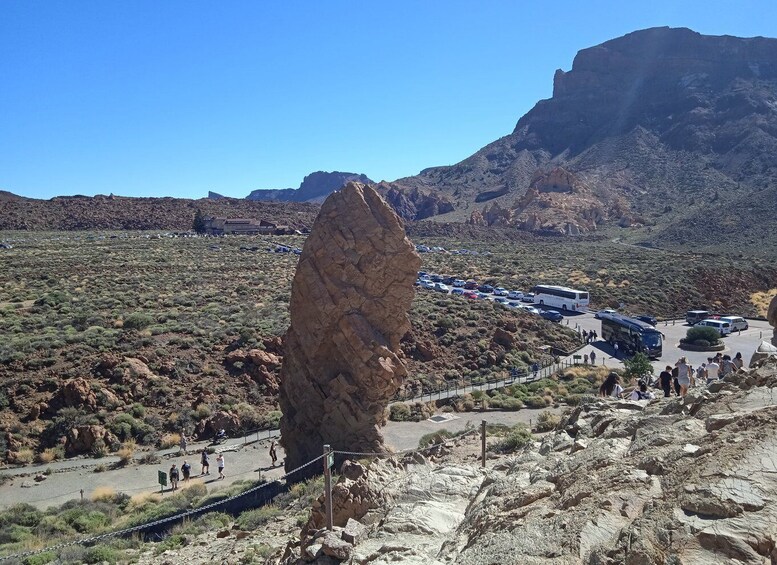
xmin=599 ymin=353 xmax=744 ymax=400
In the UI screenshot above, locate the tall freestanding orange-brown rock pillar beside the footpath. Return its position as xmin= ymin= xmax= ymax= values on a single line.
xmin=280 ymin=183 xmax=421 ymax=470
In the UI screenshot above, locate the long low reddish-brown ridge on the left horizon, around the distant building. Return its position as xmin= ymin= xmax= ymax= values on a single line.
xmin=0 ymin=192 xmax=318 ymax=231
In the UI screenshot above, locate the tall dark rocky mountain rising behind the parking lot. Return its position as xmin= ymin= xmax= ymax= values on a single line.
xmin=396 ymin=28 xmax=777 ymax=245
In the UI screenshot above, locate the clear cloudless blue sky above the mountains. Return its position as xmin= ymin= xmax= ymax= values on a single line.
xmin=0 ymin=0 xmax=777 ymax=198
